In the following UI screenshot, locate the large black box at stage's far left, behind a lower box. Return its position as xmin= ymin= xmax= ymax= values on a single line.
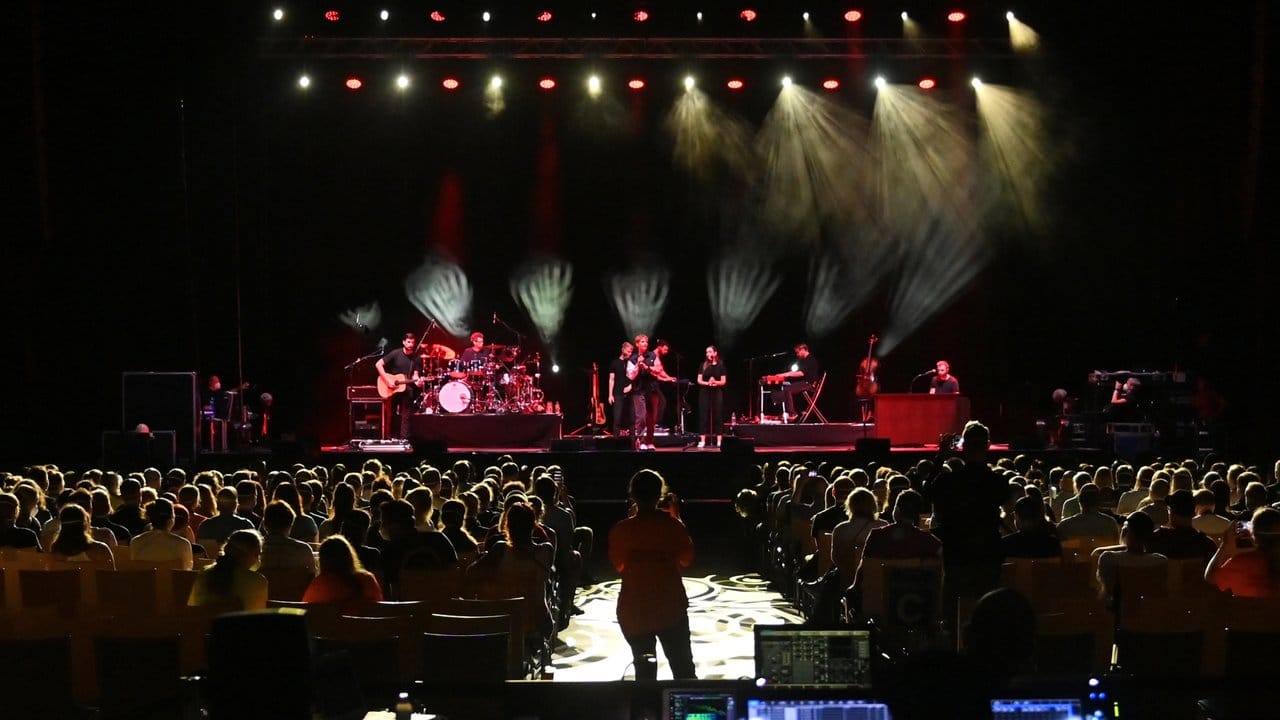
xmin=120 ymin=373 xmax=200 ymax=462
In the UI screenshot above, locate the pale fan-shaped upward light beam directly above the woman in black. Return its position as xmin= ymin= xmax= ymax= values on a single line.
xmin=707 ymin=251 xmax=782 ymax=347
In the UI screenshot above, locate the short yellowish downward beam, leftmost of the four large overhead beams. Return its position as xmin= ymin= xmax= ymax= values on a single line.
xmin=666 ymin=88 xmax=754 ymax=183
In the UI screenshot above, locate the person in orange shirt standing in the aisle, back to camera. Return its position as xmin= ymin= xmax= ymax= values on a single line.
xmin=609 ymin=470 xmax=698 ymax=680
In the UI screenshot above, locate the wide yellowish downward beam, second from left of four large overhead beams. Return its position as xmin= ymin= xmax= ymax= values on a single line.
xmin=755 ymin=85 xmax=873 ymax=243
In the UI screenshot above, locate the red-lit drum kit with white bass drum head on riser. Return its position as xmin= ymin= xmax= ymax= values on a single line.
xmin=416 ymin=345 xmax=547 ymax=415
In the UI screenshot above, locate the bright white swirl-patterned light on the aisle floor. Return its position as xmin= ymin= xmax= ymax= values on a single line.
xmin=553 ymin=574 xmax=803 ymax=680
